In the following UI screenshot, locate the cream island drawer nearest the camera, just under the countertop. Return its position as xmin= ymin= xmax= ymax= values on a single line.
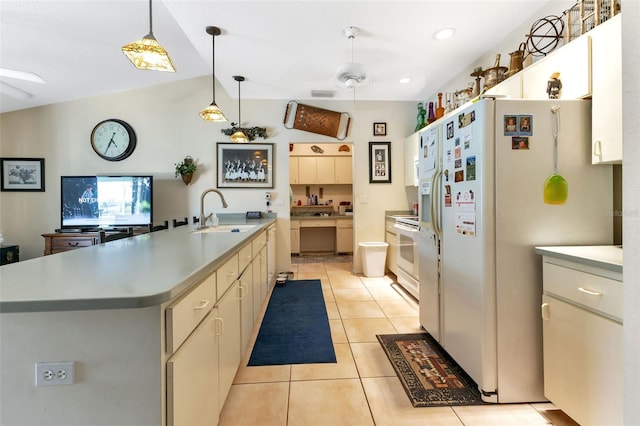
xmin=166 ymin=273 xmax=216 ymax=354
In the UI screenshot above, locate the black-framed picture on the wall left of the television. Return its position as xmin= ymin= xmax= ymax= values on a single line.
xmin=0 ymin=158 xmax=44 ymax=192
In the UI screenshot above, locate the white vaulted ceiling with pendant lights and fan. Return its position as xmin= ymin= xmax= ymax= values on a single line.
xmin=0 ymin=0 xmax=572 ymax=112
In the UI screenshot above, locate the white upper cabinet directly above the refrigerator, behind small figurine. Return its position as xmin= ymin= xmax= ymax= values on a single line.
xmin=520 ymin=34 xmax=593 ymax=99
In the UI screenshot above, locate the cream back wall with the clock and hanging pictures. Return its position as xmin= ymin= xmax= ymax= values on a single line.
xmin=0 ymin=77 xmax=415 ymax=270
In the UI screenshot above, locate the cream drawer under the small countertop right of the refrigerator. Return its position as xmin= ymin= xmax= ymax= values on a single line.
xmin=543 ymin=263 xmax=622 ymax=322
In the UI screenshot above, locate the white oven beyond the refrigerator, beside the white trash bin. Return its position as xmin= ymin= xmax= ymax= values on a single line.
xmin=394 ymin=219 xmax=420 ymax=299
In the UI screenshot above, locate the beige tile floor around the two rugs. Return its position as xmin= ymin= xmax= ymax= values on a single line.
xmin=219 ymin=263 xmax=564 ymax=426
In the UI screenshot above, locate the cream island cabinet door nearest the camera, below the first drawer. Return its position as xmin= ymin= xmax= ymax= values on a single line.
xmin=167 ymin=310 xmax=220 ymax=426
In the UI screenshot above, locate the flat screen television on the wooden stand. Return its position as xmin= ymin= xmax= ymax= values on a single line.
xmin=60 ymin=175 xmax=153 ymax=229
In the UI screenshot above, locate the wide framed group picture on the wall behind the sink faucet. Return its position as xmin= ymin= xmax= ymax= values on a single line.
xmin=217 ymin=142 xmax=273 ymax=188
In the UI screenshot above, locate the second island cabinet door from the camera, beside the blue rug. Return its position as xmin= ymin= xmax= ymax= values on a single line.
xmin=216 ymin=281 xmax=242 ymax=412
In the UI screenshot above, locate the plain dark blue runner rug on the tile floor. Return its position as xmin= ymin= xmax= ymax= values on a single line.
xmin=247 ymin=280 xmax=336 ymax=366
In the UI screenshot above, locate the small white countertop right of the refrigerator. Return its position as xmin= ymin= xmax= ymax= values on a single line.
xmin=536 ymin=246 xmax=622 ymax=273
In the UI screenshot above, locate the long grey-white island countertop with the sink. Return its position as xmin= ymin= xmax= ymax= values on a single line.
xmin=0 ymin=217 xmax=275 ymax=312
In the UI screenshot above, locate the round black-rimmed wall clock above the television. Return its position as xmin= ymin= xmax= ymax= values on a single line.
xmin=91 ymin=118 xmax=136 ymax=161
